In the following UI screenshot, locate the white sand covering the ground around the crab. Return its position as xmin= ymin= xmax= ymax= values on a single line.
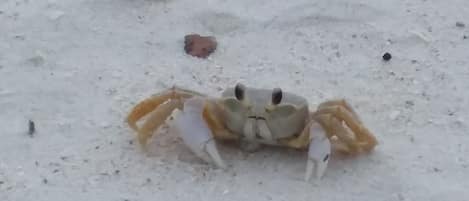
xmin=0 ymin=0 xmax=469 ymax=201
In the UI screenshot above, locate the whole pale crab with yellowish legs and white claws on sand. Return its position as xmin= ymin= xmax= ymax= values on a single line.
xmin=127 ymin=83 xmax=378 ymax=181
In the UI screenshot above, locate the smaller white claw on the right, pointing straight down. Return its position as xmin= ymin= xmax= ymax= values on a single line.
xmin=305 ymin=121 xmax=331 ymax=181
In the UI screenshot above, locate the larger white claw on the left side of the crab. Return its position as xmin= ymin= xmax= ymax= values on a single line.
xmin=171 ymin=97 xmax=226 ymax=168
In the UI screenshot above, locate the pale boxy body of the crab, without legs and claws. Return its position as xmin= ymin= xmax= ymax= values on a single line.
xmin=222 ymin=88 xmax=309 ymax=145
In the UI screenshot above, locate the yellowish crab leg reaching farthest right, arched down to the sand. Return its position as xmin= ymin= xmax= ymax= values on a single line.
xmin=314 ymin=105 xmax=378 ymax=151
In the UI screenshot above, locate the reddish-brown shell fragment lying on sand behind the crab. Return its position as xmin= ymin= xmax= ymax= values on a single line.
xmin=184 ymin=34 xmax=217 ymax=58
